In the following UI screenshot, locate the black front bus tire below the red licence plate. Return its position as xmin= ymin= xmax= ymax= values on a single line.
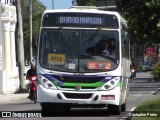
xmin=108 ymin=105 xmax=121 ymax=115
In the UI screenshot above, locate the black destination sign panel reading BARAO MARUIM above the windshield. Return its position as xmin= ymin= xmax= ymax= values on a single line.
xmin=42 ymin=12 xmax=118 ymax=28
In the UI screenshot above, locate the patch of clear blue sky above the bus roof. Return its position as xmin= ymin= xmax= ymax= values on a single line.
xmin=39 ymin=0 xmax=72 ymax=9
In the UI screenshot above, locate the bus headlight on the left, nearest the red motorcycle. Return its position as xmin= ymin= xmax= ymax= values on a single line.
xmin=38 ymin=75 xmax=57 ymax=90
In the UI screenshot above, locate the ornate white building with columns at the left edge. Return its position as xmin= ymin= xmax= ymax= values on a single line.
xmin=0 ymin=0 xmax=19 ymax=94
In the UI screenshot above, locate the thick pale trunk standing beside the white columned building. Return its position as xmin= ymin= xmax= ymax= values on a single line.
xmin=16 ymin=0 xmax=26 ymax=90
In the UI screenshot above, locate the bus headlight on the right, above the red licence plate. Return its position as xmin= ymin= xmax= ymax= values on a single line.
xmin=99 ymin=77 xmax=120 ymax=90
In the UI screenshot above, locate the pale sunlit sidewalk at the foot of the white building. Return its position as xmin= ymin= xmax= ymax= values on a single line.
xmin=0 ymin=93 xmax=28 ymax=104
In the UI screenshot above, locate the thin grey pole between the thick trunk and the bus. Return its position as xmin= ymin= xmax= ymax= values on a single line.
xmin=29 ymin=0 xmax=33 ymax=62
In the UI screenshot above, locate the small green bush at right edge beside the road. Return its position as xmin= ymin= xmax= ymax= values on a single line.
xmin=152 ymin=61 xmax=160 ymax=81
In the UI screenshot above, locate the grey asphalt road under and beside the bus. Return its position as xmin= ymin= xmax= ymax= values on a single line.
xmin=0 ymin=72 xmax=160 ymax=120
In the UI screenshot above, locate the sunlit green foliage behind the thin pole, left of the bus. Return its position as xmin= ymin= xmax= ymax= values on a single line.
xmin=21 ymin=0 xmax=46 ymax=60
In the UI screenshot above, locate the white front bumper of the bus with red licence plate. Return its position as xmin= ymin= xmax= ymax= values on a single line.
xmin=37 ymin=85 xmax=121 ymax=105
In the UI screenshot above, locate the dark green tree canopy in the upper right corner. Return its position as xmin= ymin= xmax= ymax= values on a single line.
xmin=117 ymin=0 xmax=160 ymax=44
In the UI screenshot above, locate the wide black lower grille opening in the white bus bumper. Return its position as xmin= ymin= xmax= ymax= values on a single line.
xmin=63 ymin=93 xmax=92 ymax=99
